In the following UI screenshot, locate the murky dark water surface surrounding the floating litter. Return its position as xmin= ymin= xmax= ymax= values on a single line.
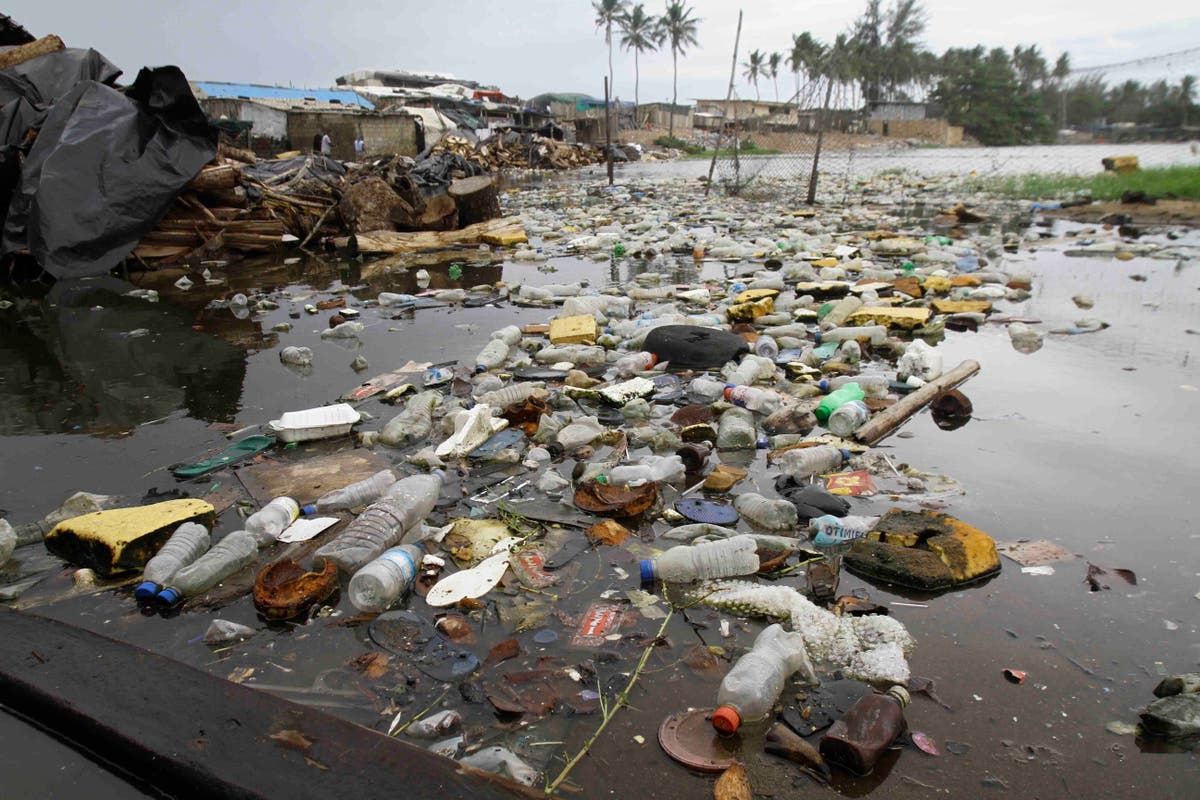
xmin=0 ymin=217 xmax=1200 ymax=799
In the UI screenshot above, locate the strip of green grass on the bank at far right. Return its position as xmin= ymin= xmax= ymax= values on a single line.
xmin=968 ymin=167 xmax=1200 ymax=200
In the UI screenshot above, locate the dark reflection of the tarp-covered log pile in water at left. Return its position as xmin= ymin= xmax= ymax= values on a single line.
xmin=0 ymin=278 xmax=252 ymax=437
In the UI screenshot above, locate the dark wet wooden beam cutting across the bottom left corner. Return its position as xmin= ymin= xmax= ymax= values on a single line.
xmin=0 ymin=609 xmax=545 ymax=800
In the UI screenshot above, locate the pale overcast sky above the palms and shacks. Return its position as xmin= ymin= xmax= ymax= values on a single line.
xmin=4 ymin=0 xmax=1200 ymax=102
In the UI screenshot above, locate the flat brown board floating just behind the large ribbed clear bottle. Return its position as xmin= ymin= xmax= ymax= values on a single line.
xmin=238 ymin=443 xmax=390 ymax=505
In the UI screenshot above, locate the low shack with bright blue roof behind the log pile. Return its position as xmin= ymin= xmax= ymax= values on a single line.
xmin=192 ymin=80 xmax=418 ymax=161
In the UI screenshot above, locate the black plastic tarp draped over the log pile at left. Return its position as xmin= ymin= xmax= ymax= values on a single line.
xmin=0 ymin=50 xmax=217 ymax=278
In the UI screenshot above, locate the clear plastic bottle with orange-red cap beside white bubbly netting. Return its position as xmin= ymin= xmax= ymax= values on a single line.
xmin=713 ymin=622 xmax=812 ymax=733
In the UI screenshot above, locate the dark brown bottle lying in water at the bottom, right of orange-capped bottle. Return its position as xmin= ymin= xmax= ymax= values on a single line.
xmin=821 ymin=686 xmax=910 ymax=775
